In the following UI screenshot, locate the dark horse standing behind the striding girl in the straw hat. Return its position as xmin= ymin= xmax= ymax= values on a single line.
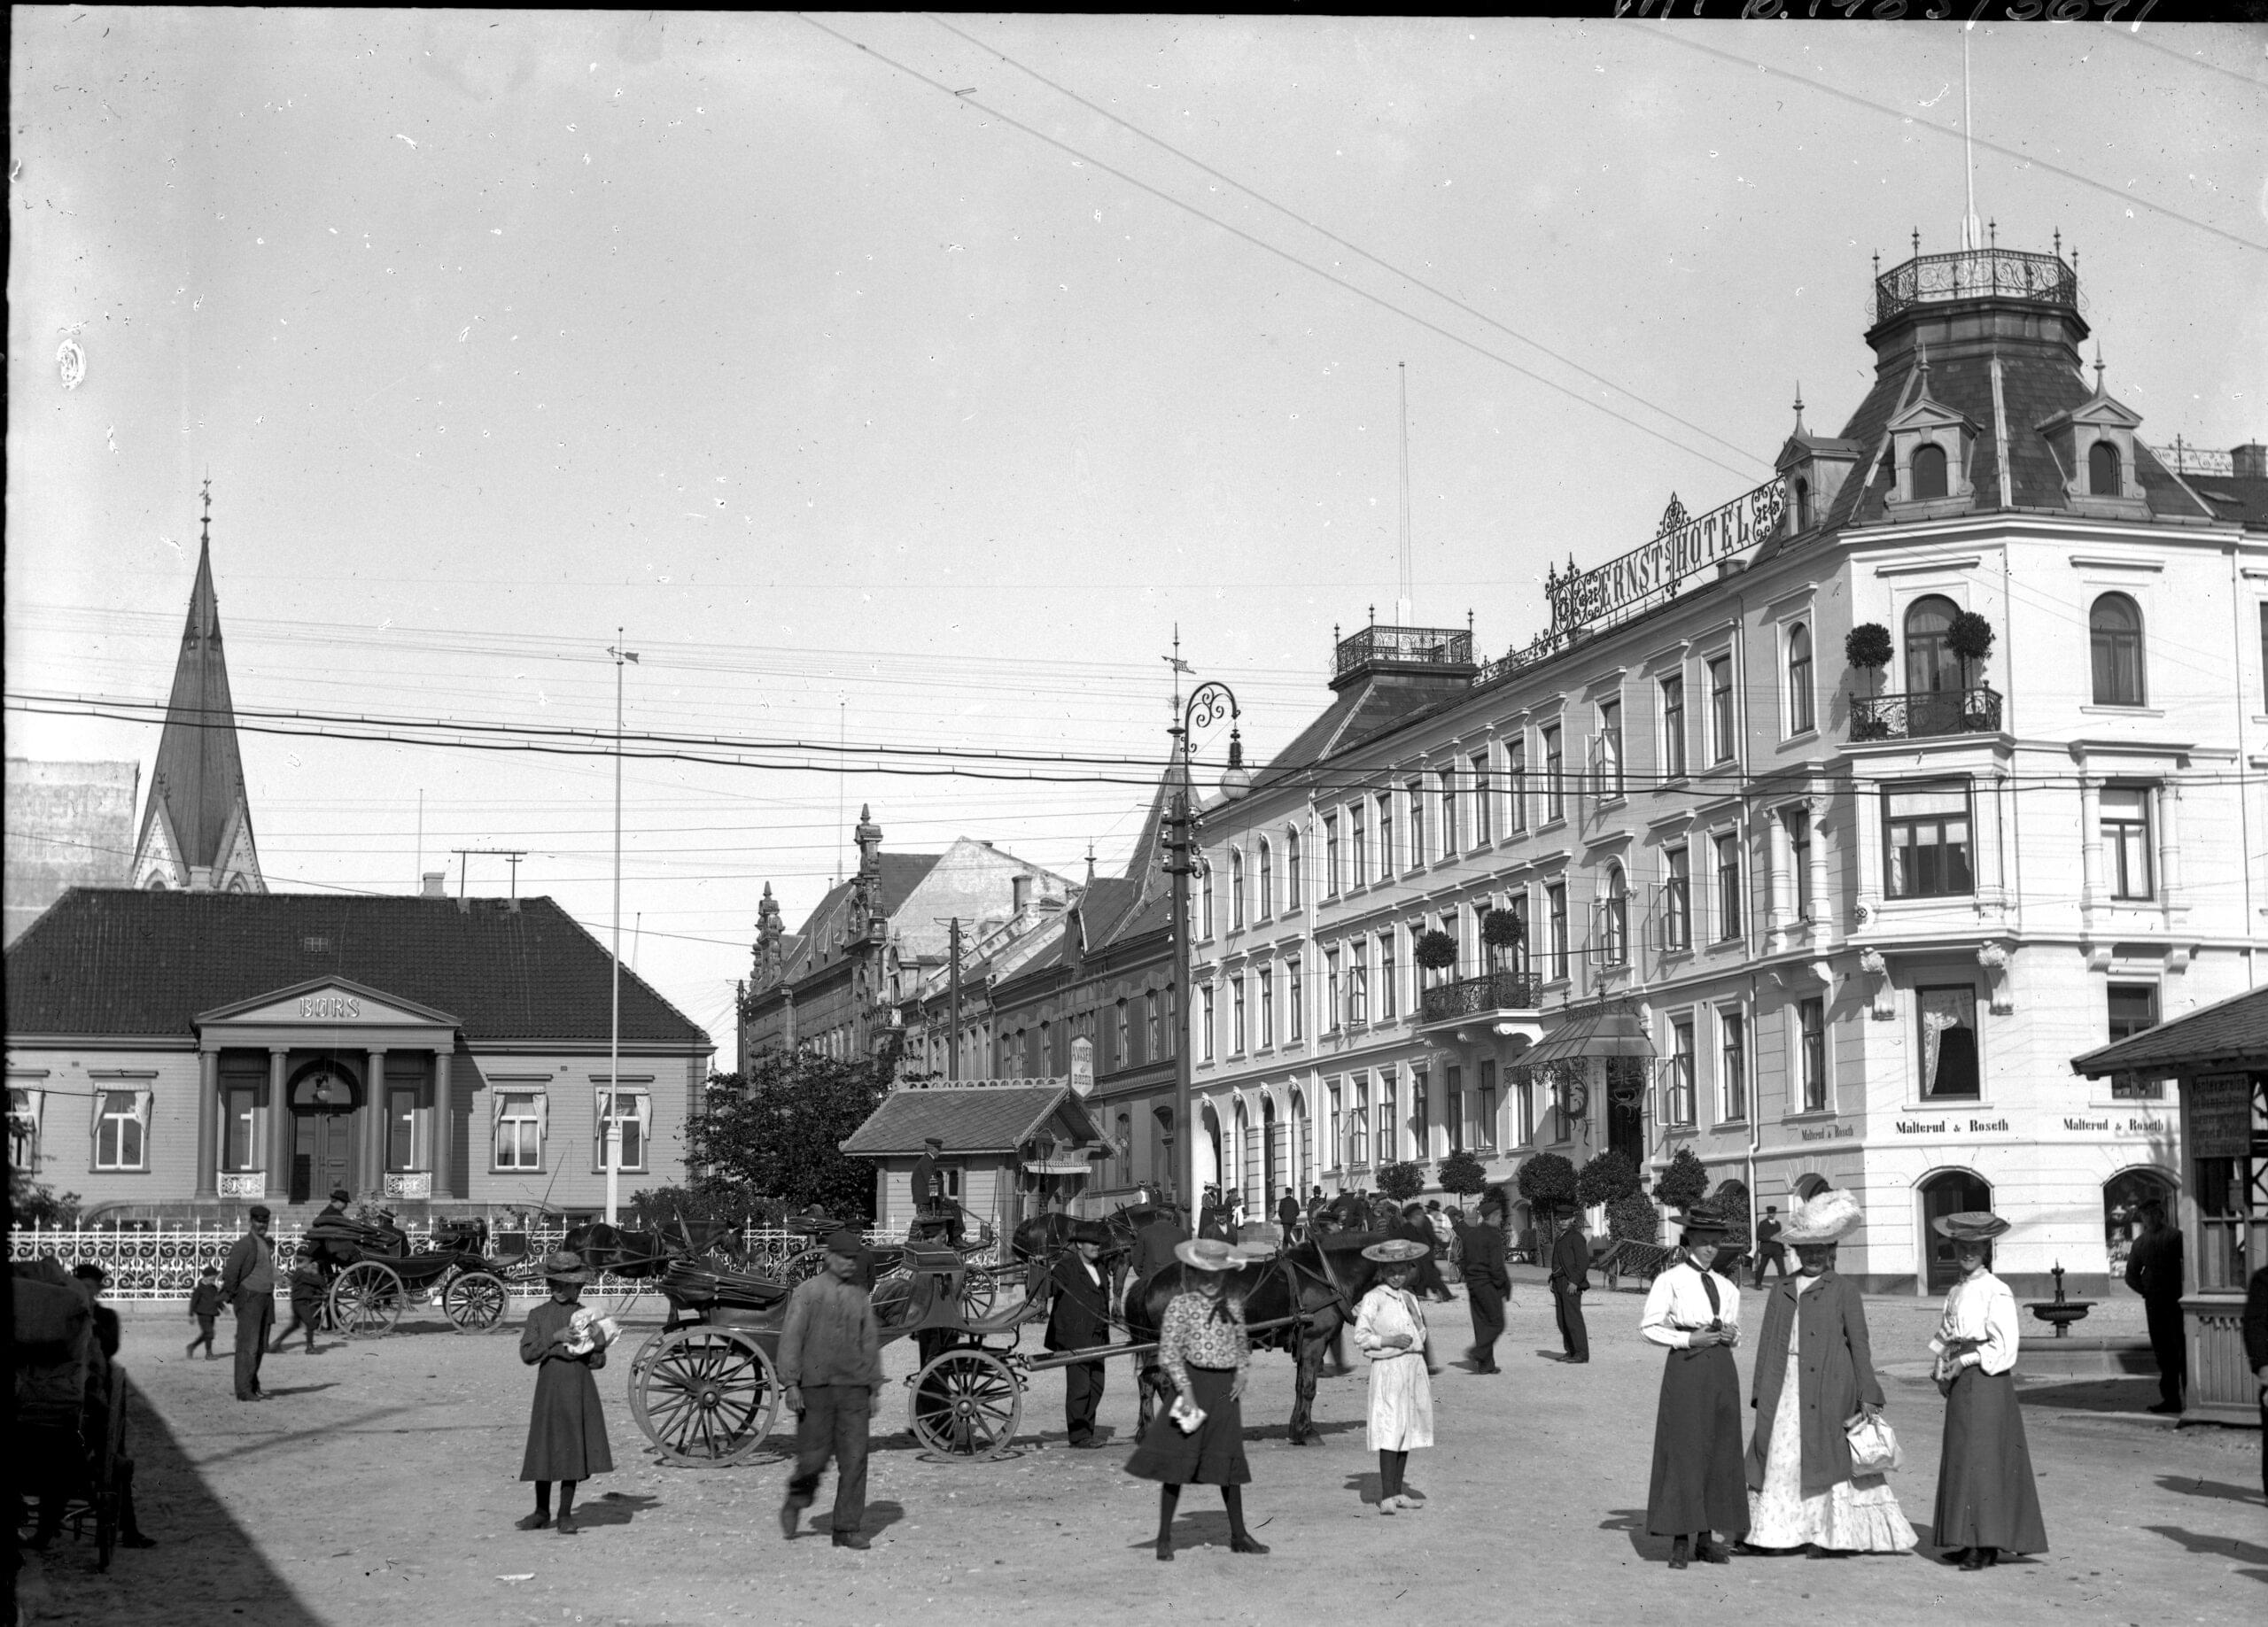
xmin=1127 ymin=1230 xmax=1384 ymax=1445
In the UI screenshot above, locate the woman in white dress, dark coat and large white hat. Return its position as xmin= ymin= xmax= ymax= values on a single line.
xmin=1742 ymin=1189 xmax=1919 ymax=1557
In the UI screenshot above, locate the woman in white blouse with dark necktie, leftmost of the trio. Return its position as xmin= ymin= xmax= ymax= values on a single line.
xmin=1637 ymin=1205 xmax=1749 ymax=1570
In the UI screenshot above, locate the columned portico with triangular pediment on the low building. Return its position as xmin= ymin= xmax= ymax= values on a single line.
xmin=195 ymin=979 xmax=462 ymax=1204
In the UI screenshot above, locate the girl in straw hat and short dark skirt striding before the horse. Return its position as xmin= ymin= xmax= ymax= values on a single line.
xmin=1127 ymin=1237 xmax=1268 ymax=1559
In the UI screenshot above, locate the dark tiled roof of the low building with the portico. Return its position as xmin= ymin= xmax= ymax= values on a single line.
xmin=7 ymin=886 xmax=710 ymax=1050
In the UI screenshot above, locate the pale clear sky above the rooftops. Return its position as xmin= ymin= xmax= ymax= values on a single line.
xmin=4 ymin=7 xmax=2268 ymax=1065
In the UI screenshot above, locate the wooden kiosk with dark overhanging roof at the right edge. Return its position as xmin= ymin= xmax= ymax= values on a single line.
xmin=2070 ymin=988 xmax=2268 ymax=1425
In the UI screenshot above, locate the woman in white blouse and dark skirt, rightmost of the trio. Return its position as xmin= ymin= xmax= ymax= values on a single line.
xmin=1930 ymin=1210 xmax=2048 ymax=1570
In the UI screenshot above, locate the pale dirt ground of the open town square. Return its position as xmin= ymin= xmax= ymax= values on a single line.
xmin=20 ymin=1281 xmax=2268 ymax=1627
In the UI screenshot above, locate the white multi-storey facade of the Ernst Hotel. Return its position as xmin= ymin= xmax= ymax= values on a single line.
xmin=1191 ymin=256 xmax=2268 ymax=1291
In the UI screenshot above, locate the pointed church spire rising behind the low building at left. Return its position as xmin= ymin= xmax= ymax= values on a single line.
xmin=134 ymin=483 xmax=266 ymax=890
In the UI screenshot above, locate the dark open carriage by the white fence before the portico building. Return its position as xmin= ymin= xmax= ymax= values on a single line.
xmin=307 ymin=1214 xmax=515 ymax=1339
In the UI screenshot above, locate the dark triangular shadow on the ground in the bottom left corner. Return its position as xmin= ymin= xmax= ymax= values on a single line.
xmin=16 ymin=1389 xmax=324 ymax=1627
